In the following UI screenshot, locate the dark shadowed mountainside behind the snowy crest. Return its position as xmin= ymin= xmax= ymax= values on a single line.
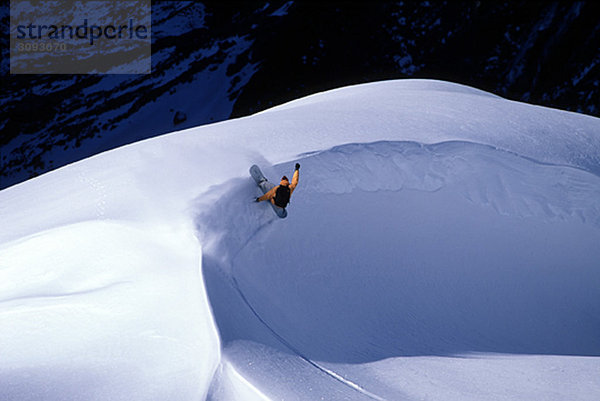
xmin=0 ymin=1 xmax=600 ymax=188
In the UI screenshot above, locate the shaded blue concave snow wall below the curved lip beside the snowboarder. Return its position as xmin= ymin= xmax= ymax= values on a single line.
xmin=197 ymin=142 xmax=600 ymax=370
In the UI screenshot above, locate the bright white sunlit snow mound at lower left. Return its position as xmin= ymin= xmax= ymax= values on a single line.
xmin=0 ymin=221 xmax=219 ymax=400
